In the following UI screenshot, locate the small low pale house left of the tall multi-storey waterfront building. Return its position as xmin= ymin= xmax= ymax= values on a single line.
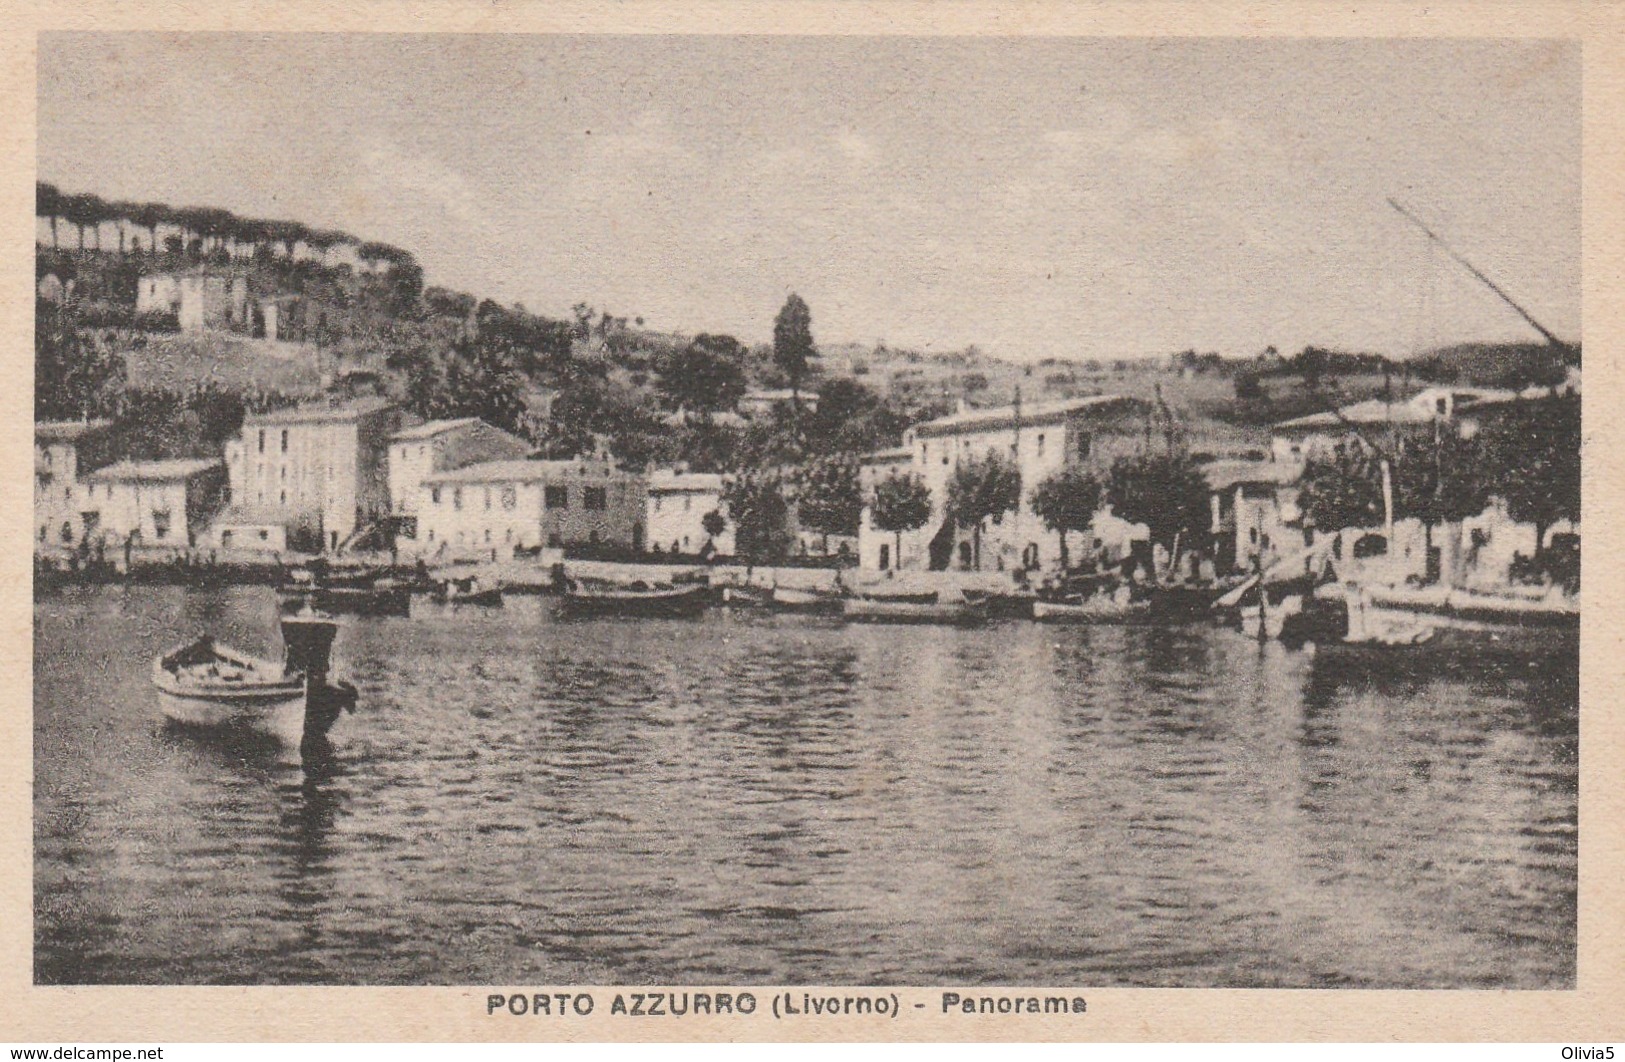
xmin=85 ymin=458 xmax=226 ymax=549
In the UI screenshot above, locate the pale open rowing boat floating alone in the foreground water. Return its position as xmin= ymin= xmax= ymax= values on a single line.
xmin=153 ymin=635 xmax=306 ymax=739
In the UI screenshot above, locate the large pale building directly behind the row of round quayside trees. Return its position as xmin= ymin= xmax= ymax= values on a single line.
xmin=858 ymin=395 xmax=1146 ymax=572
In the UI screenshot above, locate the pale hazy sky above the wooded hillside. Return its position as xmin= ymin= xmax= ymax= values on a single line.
xmin=37 ymin=32 xmax=1581 ymax=362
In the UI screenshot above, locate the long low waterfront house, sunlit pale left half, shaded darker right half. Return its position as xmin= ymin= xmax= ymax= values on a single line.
xmin=413 ymin=455 xmax=647 ymax=560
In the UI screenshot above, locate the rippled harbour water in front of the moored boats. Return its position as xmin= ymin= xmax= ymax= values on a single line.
xmin=34 ymin=583 xmax=1578 ymax=989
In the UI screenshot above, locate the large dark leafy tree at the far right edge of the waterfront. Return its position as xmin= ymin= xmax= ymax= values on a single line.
xmin=1482 ymin=393 xmax=1581 ymax=555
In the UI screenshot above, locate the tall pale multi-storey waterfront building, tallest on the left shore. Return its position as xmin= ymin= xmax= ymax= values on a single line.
xmin=215 ymin=398 xmax=400 ymax=552
